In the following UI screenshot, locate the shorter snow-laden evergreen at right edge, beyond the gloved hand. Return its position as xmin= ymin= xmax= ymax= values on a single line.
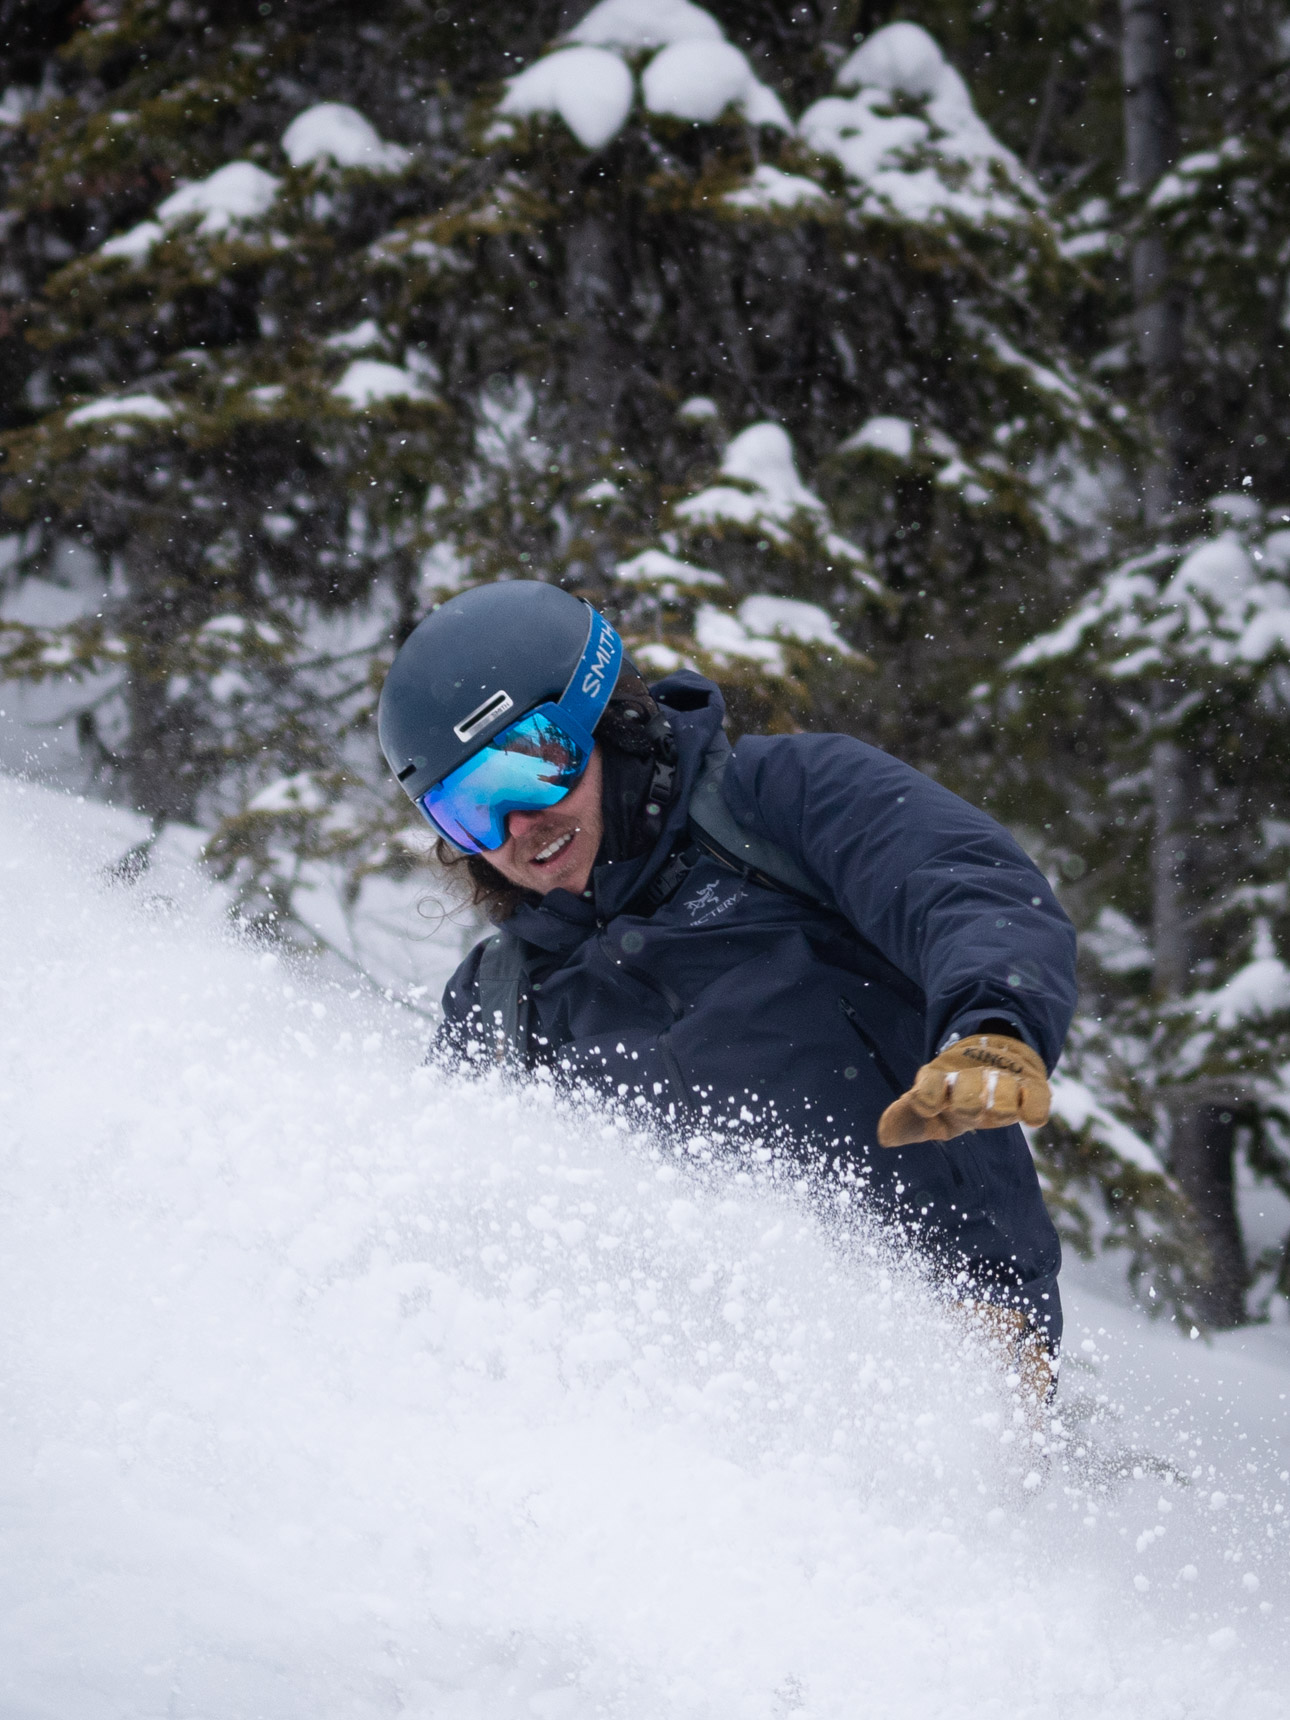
xmin=1003 ymin=492 xmax=1290 ymax=1326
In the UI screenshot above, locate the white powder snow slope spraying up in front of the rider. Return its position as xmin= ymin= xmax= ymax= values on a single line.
xmin=0 ymin=781 xmax=1290 ymax=1720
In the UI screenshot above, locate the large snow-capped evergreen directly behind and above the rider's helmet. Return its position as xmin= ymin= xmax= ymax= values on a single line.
xmin=389 ymin=0 xmax=1099 ymax=760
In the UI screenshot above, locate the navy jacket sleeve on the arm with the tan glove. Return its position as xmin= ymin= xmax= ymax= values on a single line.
xmin=722 ymin=734 xmax=1075 ymax=1070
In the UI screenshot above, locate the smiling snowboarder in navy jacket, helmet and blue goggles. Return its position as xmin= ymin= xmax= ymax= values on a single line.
xmin=380 ymin=581 xmax=1075 ymax=1391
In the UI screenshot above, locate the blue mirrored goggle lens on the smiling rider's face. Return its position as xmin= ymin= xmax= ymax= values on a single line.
xmin=416 ymin=703 xmax=595 ymax=855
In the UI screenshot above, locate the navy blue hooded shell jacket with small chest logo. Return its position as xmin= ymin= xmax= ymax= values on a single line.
xmin=439 ymin=674 xmax=1075 ymax=1340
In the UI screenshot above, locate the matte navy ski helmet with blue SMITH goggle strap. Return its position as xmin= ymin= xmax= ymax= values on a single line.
xmin=377 ymin=580 xmax=623 ymax=803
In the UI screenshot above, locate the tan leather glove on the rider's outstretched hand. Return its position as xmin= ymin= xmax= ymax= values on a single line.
xmin=877 ymin=1034 xmax=1053 ymax=1147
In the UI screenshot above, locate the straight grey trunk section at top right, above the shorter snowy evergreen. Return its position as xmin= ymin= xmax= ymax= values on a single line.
xmin=1120 ymin=0 xmax=1183 ymax=525
